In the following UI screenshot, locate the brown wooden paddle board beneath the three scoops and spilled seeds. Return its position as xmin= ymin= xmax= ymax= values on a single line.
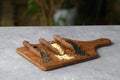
xmin=17 ymin=38 xmax=111 ymax=71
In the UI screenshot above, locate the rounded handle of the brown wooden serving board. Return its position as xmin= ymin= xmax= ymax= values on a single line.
xmin=93 ymin=38 xmax=111 ymax=48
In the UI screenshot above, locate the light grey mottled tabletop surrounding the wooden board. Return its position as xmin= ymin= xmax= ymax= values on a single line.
xmin=0 ymin=26 xmax=120 ymax=80
